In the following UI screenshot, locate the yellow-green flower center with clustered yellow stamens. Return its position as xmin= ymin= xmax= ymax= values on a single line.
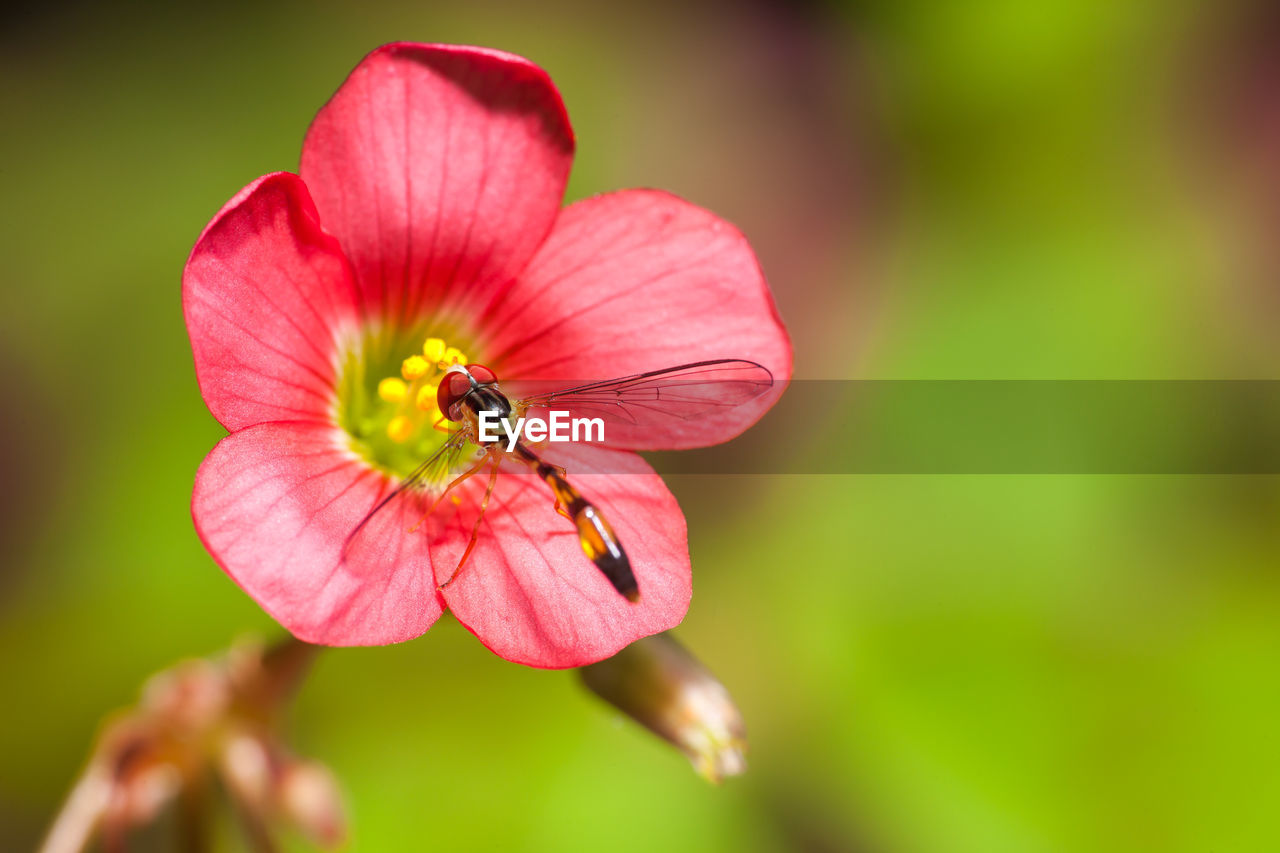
xmin=339 ymin=337 xmax=467 ymax=476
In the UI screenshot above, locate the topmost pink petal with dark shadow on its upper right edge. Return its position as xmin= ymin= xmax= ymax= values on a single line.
xmin=301 ymin=44 xmax=573 ymax=324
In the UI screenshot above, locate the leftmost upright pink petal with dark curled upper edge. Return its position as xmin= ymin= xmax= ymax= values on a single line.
xmin=182 ymin=172 xmax=357 ymax=430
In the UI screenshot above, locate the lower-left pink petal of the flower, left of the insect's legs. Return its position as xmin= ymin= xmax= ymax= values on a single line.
xmin=191 ymin=423 xmax=442 ymax=646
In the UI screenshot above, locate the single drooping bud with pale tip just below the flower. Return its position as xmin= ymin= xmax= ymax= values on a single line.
xmin=579 ymin=634 xmax=746 ymax=783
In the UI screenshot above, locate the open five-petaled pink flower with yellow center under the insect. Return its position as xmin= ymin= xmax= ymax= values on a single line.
xmin=183 ymin=44 xmax=791 ymax=667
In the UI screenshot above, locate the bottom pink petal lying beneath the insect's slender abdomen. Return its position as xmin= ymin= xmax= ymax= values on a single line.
xmin=431 ymin=444 xmax=690 ymax=667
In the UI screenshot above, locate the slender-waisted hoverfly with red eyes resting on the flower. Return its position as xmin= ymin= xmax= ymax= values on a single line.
xmin=343 ymin=359 xmax=773 ymax=602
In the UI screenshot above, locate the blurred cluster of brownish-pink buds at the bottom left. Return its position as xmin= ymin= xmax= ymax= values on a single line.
xmin=42 ymin=638 xmax=335 ymax=853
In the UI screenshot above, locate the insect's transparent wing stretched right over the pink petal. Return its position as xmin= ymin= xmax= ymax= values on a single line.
xmin=502 ymin=359 xmax=773 ymax=433
